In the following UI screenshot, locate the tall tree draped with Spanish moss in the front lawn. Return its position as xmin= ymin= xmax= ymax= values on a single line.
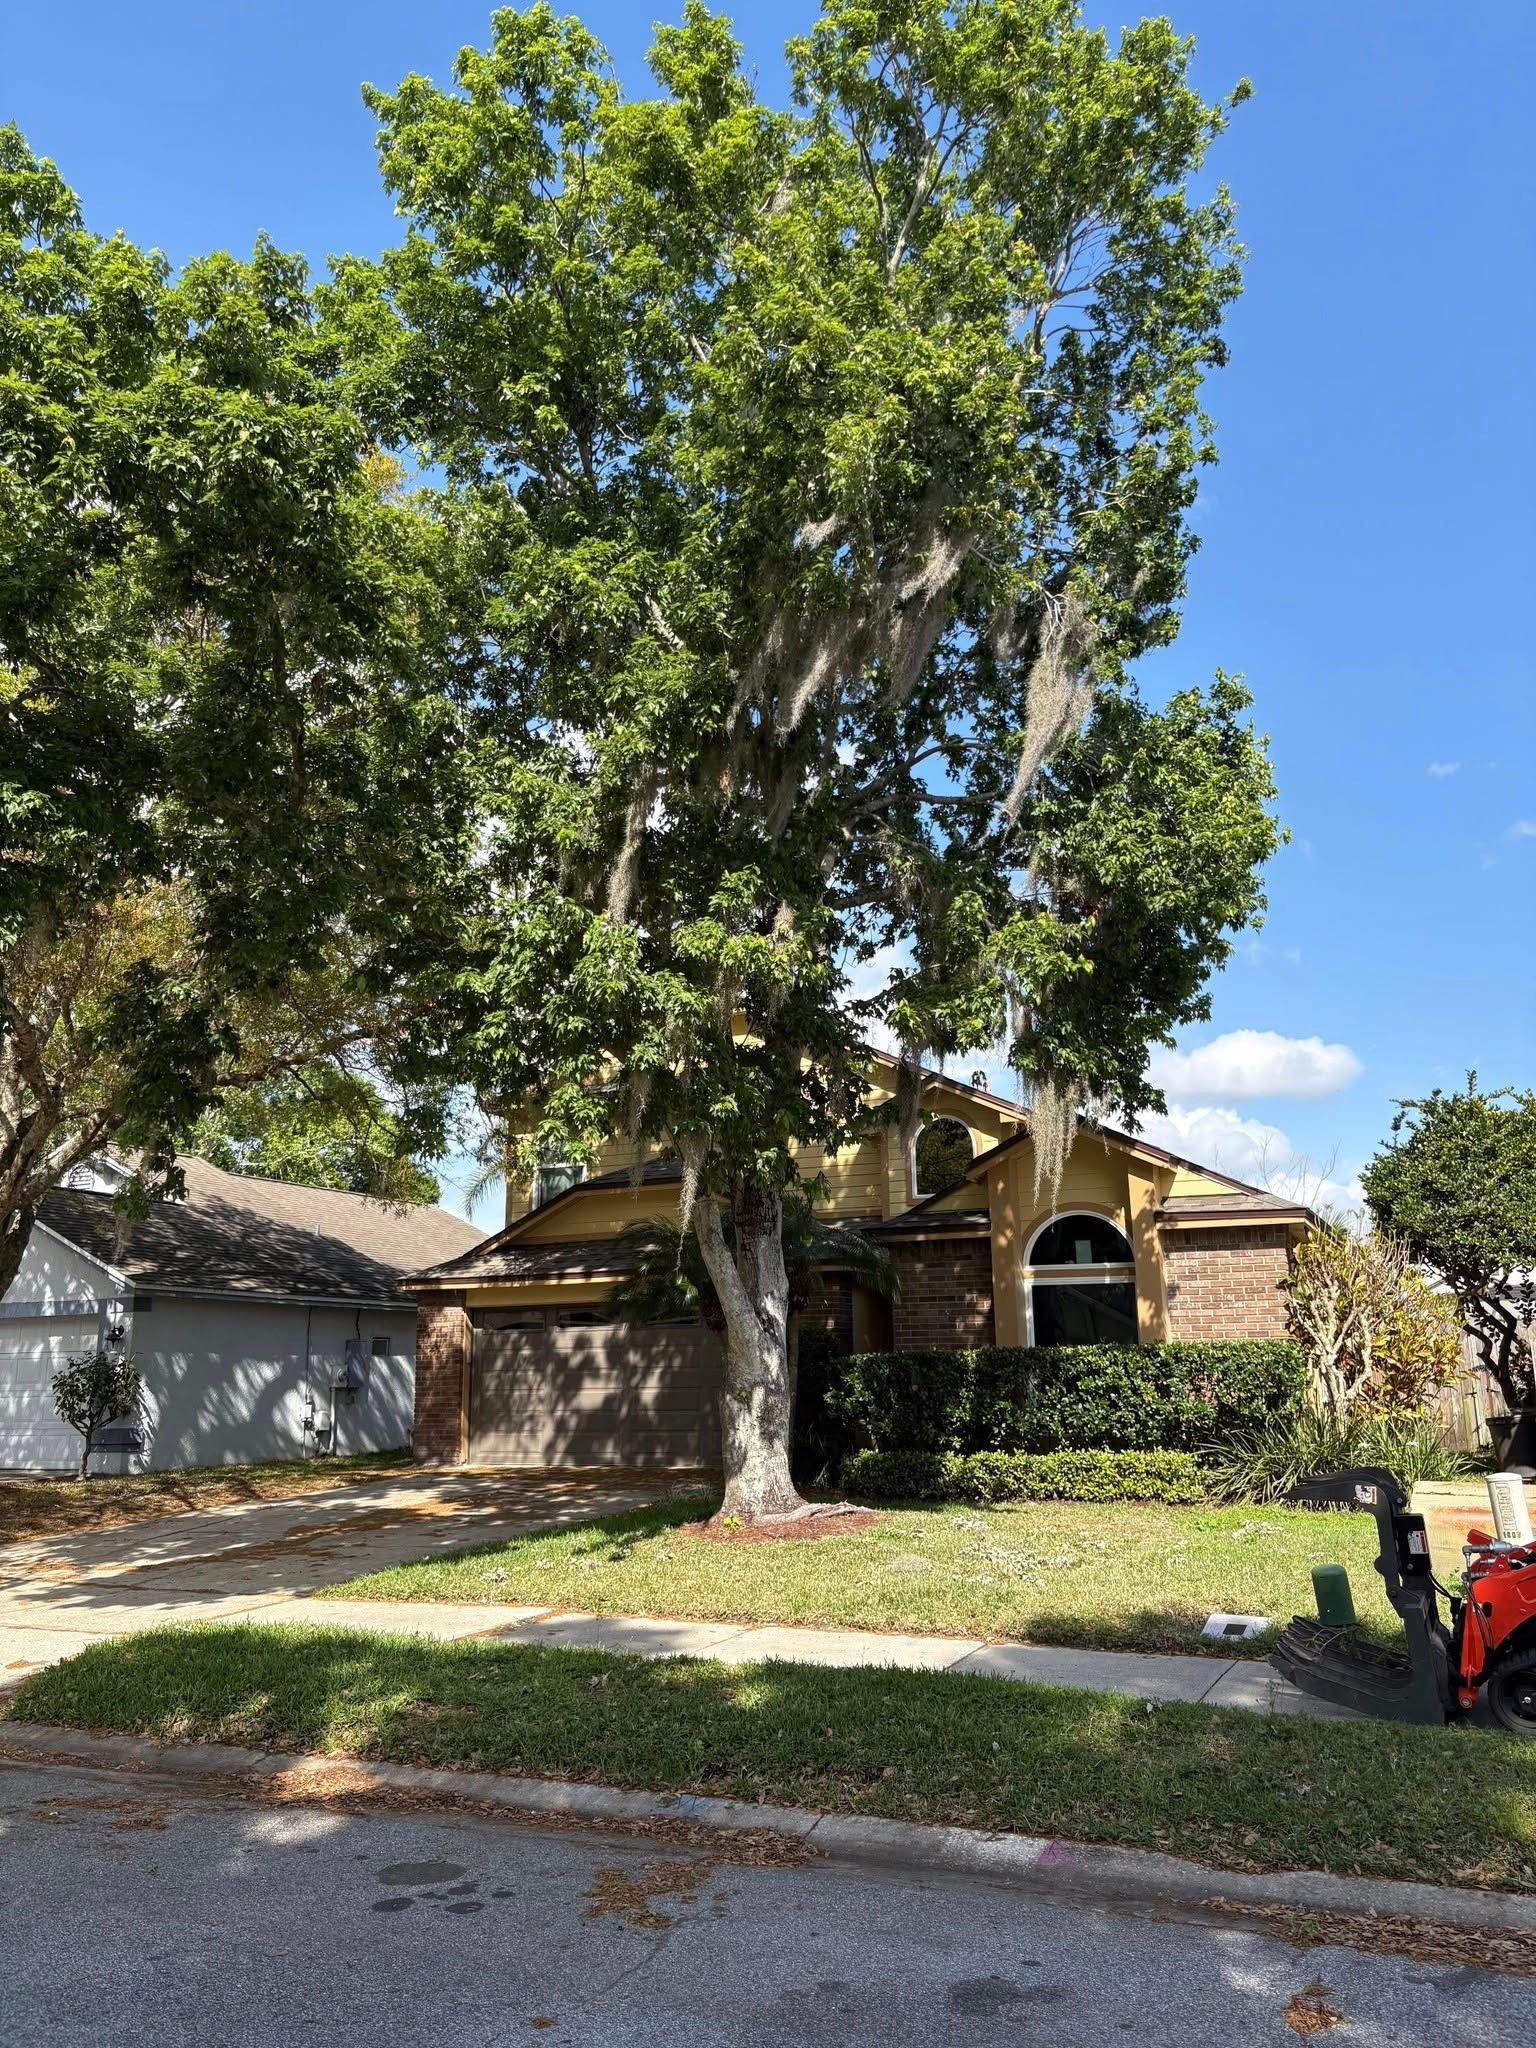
xmin=326 ymin=0 xmax=1276 ymax=1518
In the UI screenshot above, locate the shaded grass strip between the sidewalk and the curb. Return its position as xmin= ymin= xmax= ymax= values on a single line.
xmin=0 ymin=1624 xmax=1536 ymax=1890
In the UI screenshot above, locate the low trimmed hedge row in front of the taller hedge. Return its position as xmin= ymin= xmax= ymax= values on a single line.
xmin=842 ymin=1450 xmax=1206 ymax=1507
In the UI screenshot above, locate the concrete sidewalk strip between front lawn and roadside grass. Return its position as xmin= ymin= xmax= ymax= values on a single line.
xmin=10 ymin=1595 xmax=1360 ymax=1720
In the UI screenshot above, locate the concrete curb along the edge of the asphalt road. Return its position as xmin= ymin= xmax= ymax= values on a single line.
xmin=0 ymin=1720 xmax=1536 ymax=1933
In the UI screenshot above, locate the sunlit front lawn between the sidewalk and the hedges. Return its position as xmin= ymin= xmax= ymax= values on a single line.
xmin=319 ymin=1499 xmax=1397 ymax=1657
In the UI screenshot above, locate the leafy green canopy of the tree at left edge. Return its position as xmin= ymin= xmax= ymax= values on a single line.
xmin=0 ymin=127 xmax=473 ymax=1290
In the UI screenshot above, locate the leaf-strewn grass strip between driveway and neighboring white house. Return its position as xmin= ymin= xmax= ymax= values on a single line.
xmin=0 ymin=1450 xmax=412 ymax=1542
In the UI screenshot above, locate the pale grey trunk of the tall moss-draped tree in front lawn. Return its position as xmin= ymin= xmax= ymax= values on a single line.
xmin=692 ymin=1182 xmax=807 ymax=1522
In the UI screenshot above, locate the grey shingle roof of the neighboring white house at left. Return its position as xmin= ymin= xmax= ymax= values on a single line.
xmin=39 ymin=1159 xmax=483 ymax=1307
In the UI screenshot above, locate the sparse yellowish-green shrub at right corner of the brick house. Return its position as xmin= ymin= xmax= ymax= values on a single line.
xmin=1282 ymin=1225 xmax=1460 ymax=1421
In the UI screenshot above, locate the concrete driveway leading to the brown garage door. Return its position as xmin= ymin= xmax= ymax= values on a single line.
xmin=0 ymin=1473 xmax=676 ymax=1688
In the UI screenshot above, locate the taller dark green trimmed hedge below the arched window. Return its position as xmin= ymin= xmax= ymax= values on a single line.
xmin=821 ymin=1343 xmax=1305 ymax=1452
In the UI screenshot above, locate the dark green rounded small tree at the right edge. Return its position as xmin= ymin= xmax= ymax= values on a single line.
xmin=1362 ymin=1073 xmax=1536 ymax=1409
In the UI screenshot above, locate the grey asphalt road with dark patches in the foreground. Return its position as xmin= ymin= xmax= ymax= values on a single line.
xmin=0 ymin=1765 xmax=1534 ymax=2048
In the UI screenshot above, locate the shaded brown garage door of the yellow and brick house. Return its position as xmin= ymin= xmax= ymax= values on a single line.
xmin=469 ymin=1323 xmax=721 ymax=1470
